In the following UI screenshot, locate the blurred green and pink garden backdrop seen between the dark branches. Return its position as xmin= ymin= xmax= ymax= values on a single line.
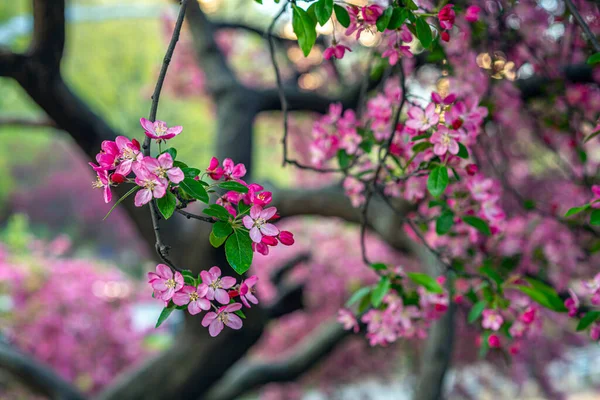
xmin=0 ymin=0 xmax=600 ymax=400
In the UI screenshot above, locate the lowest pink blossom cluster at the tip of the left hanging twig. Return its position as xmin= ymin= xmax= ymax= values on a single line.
xmin=148 ymin=264 xmax=258 ymax=337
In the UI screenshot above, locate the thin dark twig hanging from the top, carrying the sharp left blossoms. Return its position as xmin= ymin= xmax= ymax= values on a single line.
xmin=143 ymin=0 xmax=187 ymax=271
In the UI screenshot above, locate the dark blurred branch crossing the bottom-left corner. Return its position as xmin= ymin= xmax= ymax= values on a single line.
xmin=0 ymin=343 xmax=84 ymax=400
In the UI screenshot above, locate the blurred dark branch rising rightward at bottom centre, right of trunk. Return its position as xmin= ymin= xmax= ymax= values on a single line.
xmin=205 ymin=321 xmax=350 ymax=400
